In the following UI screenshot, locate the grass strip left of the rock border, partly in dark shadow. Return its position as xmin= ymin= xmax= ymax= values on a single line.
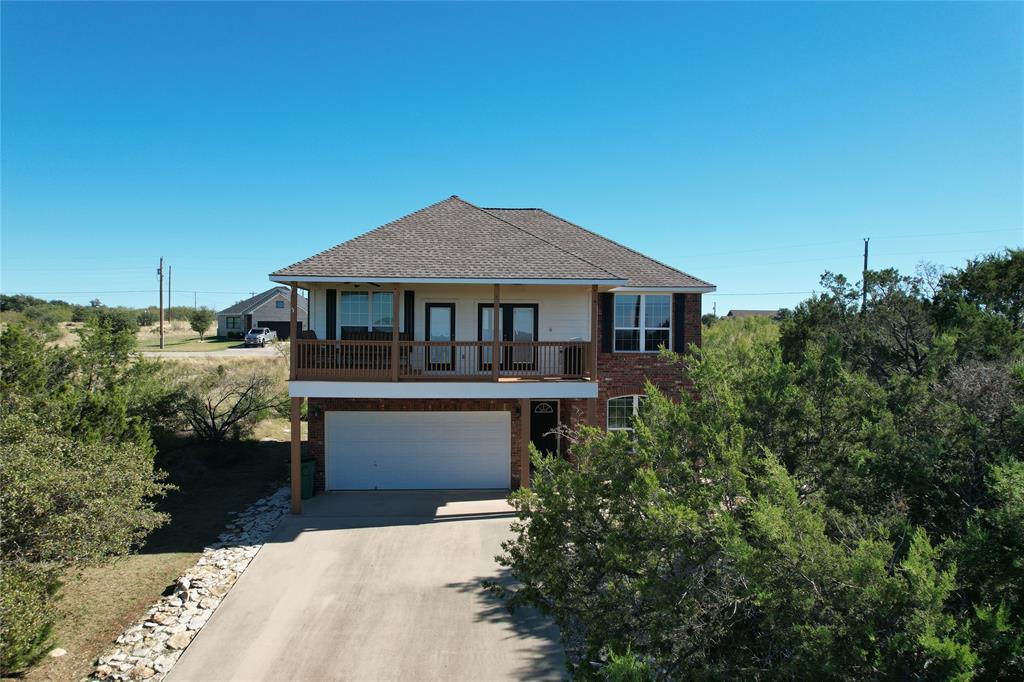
xmin=24 ymin=432 xmax=289 ymax=681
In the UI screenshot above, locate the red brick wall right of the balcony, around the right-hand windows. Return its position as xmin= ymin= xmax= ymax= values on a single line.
xmin=597 ymin=294 xmax=700 ymax=428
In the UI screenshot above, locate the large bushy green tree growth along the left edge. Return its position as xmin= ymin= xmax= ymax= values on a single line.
xmin=0 ymin=321 xmax=176 ymax=674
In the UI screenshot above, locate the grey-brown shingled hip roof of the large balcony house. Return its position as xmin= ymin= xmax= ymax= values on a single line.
xmin=271 ymin=197 xmax=713 ymax=288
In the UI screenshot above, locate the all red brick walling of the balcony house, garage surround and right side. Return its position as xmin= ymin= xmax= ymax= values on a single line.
xmin=308 ymin=294 xmax=700 ymax=492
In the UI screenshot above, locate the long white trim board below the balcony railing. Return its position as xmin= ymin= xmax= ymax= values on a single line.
xmin=288 ymin=381 xmax=597 ymax=400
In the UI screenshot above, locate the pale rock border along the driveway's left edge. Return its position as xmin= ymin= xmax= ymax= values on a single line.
xmin=85 ymin=487 xmax=292 ymax=681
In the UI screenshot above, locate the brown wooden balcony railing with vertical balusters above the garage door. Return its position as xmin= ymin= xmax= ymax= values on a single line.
xmin=294 ymin=339 xmax=592 ymax=381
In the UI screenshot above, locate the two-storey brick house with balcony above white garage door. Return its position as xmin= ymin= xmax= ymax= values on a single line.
xmin=270 ymin=197 xmax=715 ymax=513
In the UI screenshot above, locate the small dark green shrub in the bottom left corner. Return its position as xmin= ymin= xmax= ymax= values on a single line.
xmin=0 ymin=562 xmax=59 ymax=675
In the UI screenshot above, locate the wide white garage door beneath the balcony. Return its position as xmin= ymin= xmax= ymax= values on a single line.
xmin=324 ymin=412 xmax=512 ymax=491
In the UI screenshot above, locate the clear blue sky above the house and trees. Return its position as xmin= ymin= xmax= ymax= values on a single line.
xmin=0 ymin=2 xmax=1024 ymax=314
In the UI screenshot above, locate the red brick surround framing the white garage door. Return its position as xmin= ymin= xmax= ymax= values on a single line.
xmin=307 ymin=398 xmax=522 ymax=492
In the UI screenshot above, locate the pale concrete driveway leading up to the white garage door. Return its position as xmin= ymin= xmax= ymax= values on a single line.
xmin=168 ymin=491 xmax=565 ymax=682
